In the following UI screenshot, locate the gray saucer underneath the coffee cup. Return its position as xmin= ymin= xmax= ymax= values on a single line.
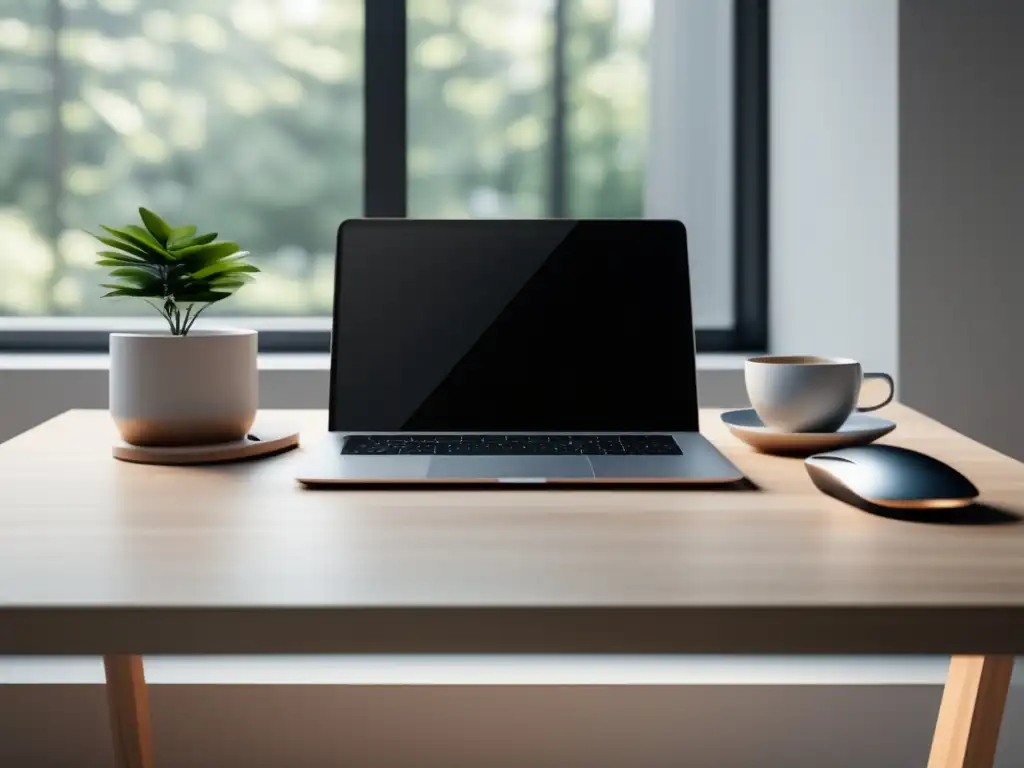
xmin=722 ymin=408 xmax=896 ymax=456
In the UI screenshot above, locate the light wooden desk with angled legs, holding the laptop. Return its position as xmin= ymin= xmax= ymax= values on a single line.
xmin=0 ymin=406 xmax=1024 ymax=768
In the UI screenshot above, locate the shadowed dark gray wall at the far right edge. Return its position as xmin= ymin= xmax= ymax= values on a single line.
xmin=899 ymin=0 xmax=1024 ymax=460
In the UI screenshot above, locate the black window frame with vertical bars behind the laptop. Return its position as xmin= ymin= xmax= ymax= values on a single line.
xmin=0 ymin=0 xmax=770 ymax=352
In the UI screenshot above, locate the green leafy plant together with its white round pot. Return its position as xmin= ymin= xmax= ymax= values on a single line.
xmin=94 ymin=208 xmax=259 ymax=445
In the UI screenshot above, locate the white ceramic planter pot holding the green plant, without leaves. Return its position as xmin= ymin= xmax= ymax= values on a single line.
xmin=110 ymin=331 xmax=259 ymax=445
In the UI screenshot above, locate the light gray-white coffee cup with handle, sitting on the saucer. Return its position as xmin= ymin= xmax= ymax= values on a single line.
xmin=743 ymin=355 xmax=896 ymax=432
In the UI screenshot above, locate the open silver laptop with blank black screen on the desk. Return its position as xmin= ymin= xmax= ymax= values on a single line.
xmin=298 ymin=219 xmax=742 ymax=485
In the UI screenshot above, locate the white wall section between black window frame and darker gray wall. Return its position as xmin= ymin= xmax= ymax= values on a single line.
xmin=769 ymin=0 xmax=898 ymax=376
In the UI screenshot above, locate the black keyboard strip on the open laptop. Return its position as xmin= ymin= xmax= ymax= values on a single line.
xmin=341 ymin=434 xmax=683 ymax=456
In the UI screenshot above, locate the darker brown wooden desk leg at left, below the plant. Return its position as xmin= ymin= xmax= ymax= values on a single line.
xmin=103 ymin=653 xmax=154 ymax=768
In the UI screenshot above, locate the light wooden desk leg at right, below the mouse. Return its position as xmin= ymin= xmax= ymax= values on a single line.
xmin=928 ymin=656 xmax=1014 ymax=768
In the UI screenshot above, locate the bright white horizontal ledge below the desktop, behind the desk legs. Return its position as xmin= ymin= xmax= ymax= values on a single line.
xmin=0 ymin=655 xmax=974 ymax=686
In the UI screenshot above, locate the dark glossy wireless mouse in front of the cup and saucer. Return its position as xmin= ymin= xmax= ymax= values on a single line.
xmin=804 ymin=445 xmax=978 ymax=509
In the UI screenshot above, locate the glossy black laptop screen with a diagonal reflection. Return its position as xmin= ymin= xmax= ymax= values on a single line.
xmin=331 ymin=219 xmax=697 ymax=432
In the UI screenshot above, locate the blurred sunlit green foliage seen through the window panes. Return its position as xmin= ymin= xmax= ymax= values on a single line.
xmin=0 ymin=0 xmax=651 ymax=315
